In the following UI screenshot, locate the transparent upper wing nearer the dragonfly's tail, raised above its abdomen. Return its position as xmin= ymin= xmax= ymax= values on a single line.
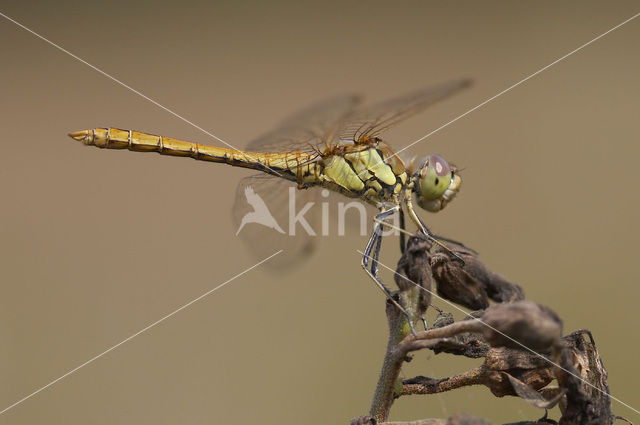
xmin=246 ymin=95 xmax=360 ymax=152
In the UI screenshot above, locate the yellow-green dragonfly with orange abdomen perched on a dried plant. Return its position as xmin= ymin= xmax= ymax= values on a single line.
xmin=69 ymin=79 xmax=471 ymax=331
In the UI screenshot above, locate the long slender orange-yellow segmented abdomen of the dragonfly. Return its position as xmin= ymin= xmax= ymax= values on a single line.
xmin=69 ymin=128 xmax=316 ymax=177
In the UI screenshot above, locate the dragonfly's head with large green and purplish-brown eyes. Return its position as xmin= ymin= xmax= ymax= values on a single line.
xmin=413 ymin=154 xmax=462 ymax=212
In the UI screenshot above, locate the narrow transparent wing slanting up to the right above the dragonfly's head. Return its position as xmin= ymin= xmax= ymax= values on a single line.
xmin=338 ymin=79 xmax=471 ymax=143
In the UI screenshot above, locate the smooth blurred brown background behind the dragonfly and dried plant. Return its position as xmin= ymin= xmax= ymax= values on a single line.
xmin=0 ymin=0 xmax=640 ymax=425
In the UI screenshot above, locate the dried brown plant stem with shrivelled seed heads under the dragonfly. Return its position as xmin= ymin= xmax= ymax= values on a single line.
xmin=351 ymin=237 xmax=616 ymax=425
